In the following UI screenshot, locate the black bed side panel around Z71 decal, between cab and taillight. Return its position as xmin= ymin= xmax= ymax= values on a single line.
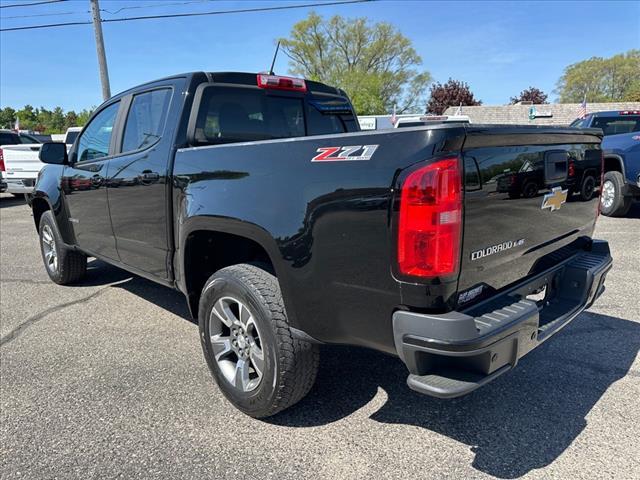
xmin=174 ymin=128 xmax=464 ymax=352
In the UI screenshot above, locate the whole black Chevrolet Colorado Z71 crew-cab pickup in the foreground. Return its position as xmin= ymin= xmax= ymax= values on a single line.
xmin=30 ymin=72 xmax=612 ymax=417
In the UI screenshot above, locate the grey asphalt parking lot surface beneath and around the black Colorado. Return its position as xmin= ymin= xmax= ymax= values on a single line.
xmin=0 ymin=194 xmax=640 ymax=479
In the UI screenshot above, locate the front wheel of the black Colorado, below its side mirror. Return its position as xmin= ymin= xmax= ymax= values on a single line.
xmin=38 ymin=210 xmax=87 ymax=285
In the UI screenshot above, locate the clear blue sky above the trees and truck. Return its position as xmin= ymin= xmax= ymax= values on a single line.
xmin=0 ymin=0 xmax=640 ymax=110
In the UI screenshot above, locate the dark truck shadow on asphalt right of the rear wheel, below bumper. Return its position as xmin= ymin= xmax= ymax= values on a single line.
xmin=266 ymin=313 xmax=640 ymax=478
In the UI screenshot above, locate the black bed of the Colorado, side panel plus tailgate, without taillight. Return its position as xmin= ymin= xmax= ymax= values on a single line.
xmin=173 ymin=125 xmax=600 ymax=352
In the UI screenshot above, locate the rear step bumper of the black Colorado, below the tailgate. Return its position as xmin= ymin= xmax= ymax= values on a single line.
xmin=393 ymin=241 xmax=612 ymax=398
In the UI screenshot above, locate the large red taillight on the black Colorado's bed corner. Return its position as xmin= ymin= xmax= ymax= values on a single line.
xmin=398 ymin=157 xmax=462 ymax=277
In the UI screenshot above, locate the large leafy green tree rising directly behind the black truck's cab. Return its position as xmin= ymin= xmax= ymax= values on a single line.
xmin=280 ymin=12 xmax=431 ymax=115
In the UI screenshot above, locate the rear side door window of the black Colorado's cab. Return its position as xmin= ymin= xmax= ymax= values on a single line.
xmin=122 ymin=88 xmax=171 ymax=152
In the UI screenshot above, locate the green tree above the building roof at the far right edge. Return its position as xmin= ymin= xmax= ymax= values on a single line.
xmin=556 ymin=49 xmax=640 ymax=103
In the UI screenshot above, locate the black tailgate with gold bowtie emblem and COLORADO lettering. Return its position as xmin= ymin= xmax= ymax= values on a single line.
xmin=458 ymin=125 xmax=602 ymax=304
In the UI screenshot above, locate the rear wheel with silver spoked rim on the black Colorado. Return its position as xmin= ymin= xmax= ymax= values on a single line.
xmin=198 ymin=264 xmax=319 ymax=418
